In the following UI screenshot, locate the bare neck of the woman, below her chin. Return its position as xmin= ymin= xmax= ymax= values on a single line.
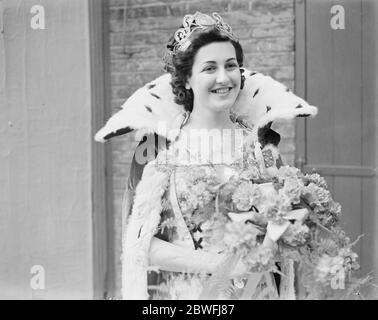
xmin=187 ymin=108 xmax=235 ymax=130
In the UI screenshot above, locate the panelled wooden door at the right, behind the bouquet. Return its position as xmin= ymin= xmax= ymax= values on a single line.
xmin=296 ymin=0 xmax=378 ymax=274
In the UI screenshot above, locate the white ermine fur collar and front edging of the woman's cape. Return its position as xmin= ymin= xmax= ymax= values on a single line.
xmin=95 ymin=70 xmax=317 ymax=299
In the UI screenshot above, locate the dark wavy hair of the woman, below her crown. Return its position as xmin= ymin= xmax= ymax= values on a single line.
xmin=167 ymin=27 xmax=244 ymax=112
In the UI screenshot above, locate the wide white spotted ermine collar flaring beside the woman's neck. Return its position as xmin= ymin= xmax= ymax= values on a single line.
xmin=95 ymin=69 xmax=317 ymax=142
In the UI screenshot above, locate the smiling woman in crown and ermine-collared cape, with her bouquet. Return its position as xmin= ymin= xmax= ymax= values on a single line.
xmin=96 ymin=5 xmax=368 ymax=300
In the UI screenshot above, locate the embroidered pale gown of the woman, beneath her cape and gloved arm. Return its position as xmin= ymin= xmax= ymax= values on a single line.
xmin=142 ymin=125 xmax=279 ymax=299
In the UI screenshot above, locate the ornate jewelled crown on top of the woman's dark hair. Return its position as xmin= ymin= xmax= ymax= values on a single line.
xmin=164 ymin=11 xmax=238 ymax=70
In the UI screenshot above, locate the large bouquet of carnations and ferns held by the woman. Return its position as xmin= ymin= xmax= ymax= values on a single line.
xmin=199 ymin=162 xmax=370 ymax=299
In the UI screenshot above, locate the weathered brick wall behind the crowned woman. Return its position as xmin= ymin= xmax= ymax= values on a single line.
xmin=108 ymin=0 xmax=295 ymax=298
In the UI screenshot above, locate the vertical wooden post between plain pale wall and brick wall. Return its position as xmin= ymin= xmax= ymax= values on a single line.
xmin=87 ymin=0 xmax=112 ymax=299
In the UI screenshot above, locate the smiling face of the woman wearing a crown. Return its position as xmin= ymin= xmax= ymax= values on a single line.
xmin=187 ymin=42 xmax=241 ymax=111
